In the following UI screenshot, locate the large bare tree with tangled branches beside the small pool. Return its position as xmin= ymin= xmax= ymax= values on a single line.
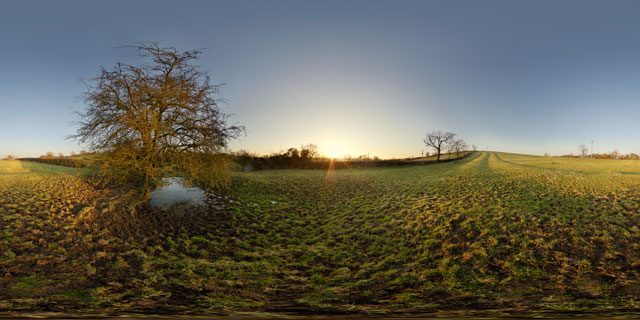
xmin=70 ymin=43 xmax=244 ymax=199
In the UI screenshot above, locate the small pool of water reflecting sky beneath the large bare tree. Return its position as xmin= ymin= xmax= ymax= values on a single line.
xmin=151 ymin=177 xmax=207 ymax=206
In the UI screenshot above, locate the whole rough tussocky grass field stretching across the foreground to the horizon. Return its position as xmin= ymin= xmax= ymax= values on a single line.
xmin=0 ymin=152 xmax=640 ymax=312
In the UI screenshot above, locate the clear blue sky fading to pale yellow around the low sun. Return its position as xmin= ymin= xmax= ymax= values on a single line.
xmin=0 ymin=0 xmax=640 ymax=158
